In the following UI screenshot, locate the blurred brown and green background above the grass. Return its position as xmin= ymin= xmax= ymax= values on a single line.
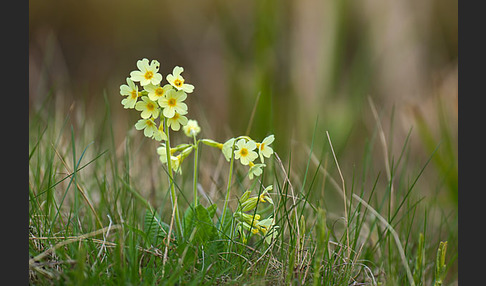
xmin=29 ymin=0 xmax=458 ymax=206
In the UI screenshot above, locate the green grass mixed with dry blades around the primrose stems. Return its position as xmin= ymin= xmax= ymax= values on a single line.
xmin=29 ymin=92 xmax=457 ymax=285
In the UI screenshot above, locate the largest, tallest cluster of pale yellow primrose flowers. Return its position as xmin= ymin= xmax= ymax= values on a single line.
xmin=120 ymin=58 xmax=194 ymax=141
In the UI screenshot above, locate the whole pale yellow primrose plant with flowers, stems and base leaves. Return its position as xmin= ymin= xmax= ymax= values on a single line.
xmin=120 ymin=58 xmax=278 ymax=248
